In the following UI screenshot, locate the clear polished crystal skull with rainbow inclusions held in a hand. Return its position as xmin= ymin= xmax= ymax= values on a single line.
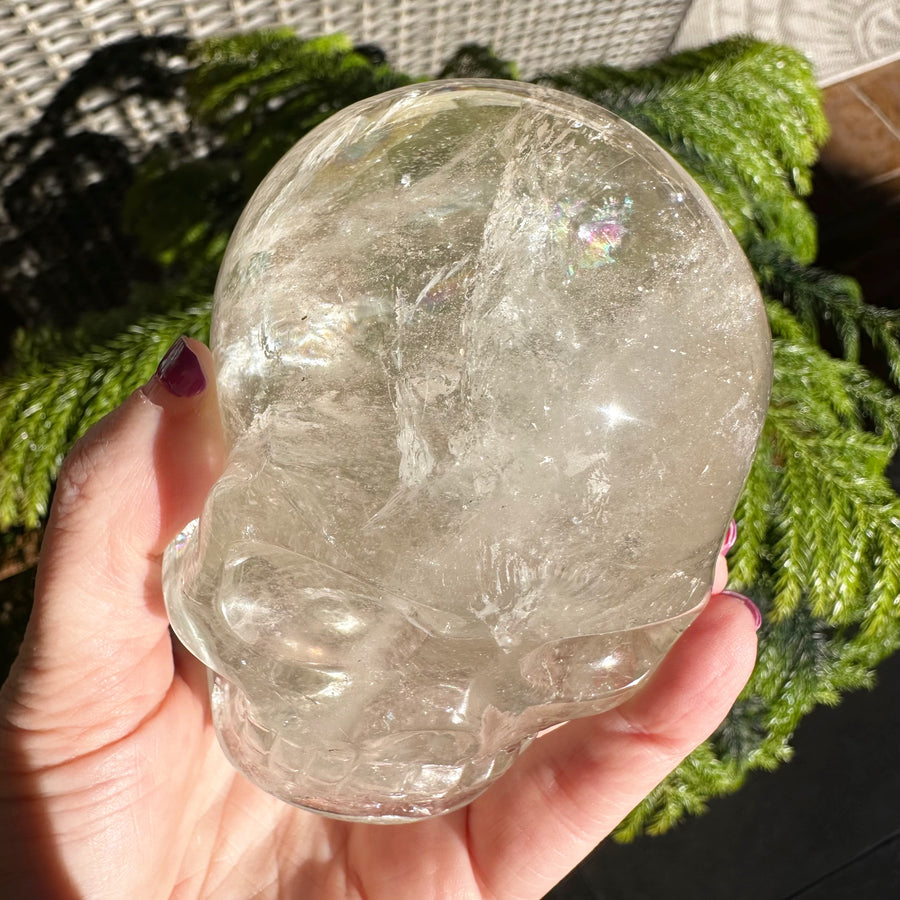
xmin=164 ymin=80 xmax=771 ymax=822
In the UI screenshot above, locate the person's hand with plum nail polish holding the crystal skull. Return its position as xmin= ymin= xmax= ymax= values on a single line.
xmin=0 ymin=340 xmax=756 ymax=900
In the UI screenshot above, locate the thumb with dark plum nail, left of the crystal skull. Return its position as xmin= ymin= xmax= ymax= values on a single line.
xmin=5 ymin=338 xmax=224 ymax=740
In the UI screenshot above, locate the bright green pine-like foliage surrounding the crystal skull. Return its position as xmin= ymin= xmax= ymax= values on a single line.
xmin=0 ymin=32 xmax=900 ymax=839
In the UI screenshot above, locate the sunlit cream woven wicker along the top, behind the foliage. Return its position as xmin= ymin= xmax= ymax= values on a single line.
xmin=0 ymin=0 xmax=690 ymax=135
